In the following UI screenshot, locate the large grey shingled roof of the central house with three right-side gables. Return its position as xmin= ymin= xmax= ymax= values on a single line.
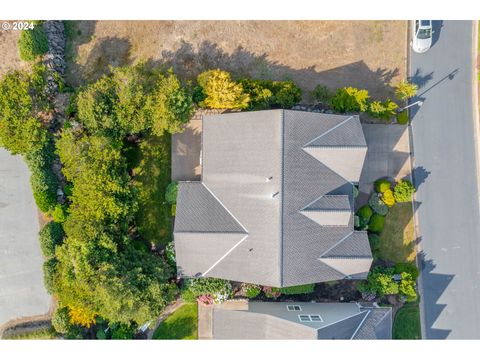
xmin=174 ymin=110 xmax=372 ymax=287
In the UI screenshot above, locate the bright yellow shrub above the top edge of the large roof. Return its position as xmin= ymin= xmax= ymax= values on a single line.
xmin=197 ymin=69 xmax=250 ymax=109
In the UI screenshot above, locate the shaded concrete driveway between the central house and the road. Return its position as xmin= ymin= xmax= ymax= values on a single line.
xmin=359 ymin=124 xmax=410 ymax=200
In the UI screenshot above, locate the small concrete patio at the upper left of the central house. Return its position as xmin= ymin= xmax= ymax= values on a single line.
xmin=172 ymin=118 xmax=202 ymax=181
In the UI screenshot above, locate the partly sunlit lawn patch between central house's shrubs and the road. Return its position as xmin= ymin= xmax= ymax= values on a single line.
xmin=378 ymin=203 xmax=416 ymax=263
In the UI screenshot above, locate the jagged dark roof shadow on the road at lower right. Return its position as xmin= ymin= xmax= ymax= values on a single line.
xmin=418 ymin=251 xmax=454 ymax=339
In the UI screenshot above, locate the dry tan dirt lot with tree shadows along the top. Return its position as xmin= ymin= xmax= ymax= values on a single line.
xmin=68 ymin=21 xmax=407 ymax=98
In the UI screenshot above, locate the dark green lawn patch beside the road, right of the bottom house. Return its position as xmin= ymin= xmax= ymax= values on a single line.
xmin=393 ymin=303 xmax=422 ymax=340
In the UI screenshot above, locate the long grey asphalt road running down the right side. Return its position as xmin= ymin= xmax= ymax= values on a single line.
xmin=410 ymin=21 xmax=480 ymax=339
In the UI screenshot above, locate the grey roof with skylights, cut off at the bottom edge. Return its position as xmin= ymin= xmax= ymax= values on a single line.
xmin=212 ymin=302 xmax=392 ymax=340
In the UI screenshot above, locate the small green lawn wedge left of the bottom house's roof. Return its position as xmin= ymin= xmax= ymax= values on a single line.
xmin=153 ymin=303 xmax=198 ymax=340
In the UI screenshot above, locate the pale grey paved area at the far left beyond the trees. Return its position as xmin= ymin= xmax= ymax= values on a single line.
xmin=0 ymin=148 xmax=50 ymax=325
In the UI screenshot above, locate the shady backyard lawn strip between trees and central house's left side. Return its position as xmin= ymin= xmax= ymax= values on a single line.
xmin=127 ymin=134 xmax=172 ymax=247
